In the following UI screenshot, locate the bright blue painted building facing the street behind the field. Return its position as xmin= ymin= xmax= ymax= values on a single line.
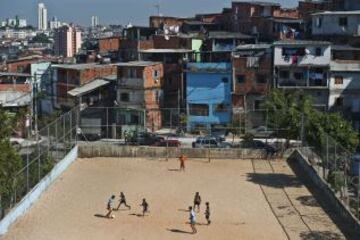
xmin=186 ymin=63 xmax=232 ymax=131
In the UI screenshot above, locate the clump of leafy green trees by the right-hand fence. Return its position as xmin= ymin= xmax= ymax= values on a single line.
xmin=264 ymin=89 xmax=359 ymax=152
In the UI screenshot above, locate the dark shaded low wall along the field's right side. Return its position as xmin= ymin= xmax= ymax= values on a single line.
xmin=289 ymin=150 xmax=360 ymax=233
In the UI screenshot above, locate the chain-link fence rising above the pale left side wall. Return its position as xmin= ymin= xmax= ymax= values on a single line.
xmin=0 ymin=108 xmax=78 ymax=219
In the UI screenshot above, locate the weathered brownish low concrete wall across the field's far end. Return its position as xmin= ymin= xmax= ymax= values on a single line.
xmin=79 ymin=143 xmax=266 ymax=159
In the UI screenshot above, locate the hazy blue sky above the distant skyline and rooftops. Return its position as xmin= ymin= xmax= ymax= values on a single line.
xmin=0 ymin=0 xmax=298 ymax=26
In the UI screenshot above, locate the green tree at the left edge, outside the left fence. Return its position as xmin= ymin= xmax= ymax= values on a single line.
xmin=0 ymin=108 xmax=23 ymax=216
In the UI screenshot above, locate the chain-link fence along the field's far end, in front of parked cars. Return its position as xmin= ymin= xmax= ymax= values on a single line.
xmin=79 ymin=107 xmax=299 ymax=153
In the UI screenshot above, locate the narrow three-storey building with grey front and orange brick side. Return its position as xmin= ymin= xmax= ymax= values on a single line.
xmin=117 ymin=61 xmax=164 ymax=131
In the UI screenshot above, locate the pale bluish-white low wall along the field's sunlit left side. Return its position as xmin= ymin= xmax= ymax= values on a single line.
xmin=0 ymin=146 xmax=78 ymax=235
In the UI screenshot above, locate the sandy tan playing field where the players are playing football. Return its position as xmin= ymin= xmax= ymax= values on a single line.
xmin=3 ymin=158 xmax=344 ymax=240
